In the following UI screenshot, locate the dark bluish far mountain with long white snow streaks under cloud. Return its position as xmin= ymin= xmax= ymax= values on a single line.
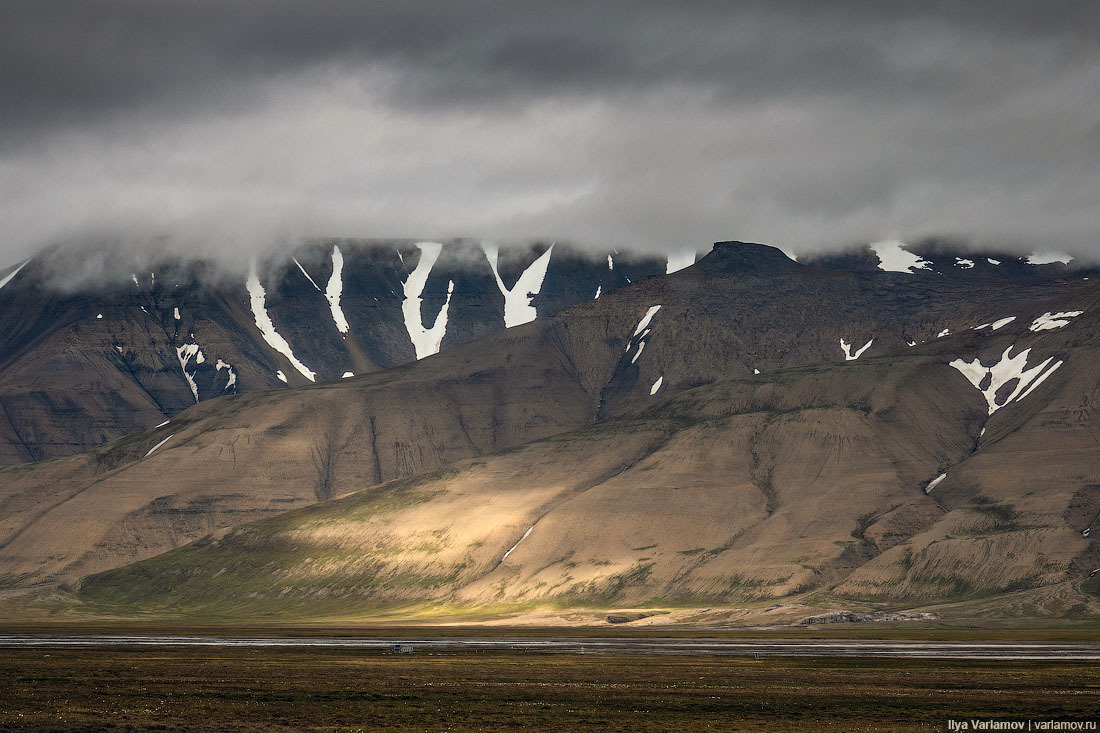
xmin=0 ymin=240 xmax=668 ymax=464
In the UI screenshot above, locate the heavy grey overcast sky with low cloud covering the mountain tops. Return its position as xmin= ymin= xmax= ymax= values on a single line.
xmin=0 ymin=0 xmax=1100 ymax=266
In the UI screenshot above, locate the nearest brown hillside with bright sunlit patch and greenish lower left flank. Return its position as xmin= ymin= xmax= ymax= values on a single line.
xmin=81 ymin=323 xmax=1100 ymax=615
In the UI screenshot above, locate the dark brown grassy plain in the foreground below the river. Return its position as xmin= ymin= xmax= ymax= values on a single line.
xmin=0 ymin=647 xmax=1100 ymax=731
